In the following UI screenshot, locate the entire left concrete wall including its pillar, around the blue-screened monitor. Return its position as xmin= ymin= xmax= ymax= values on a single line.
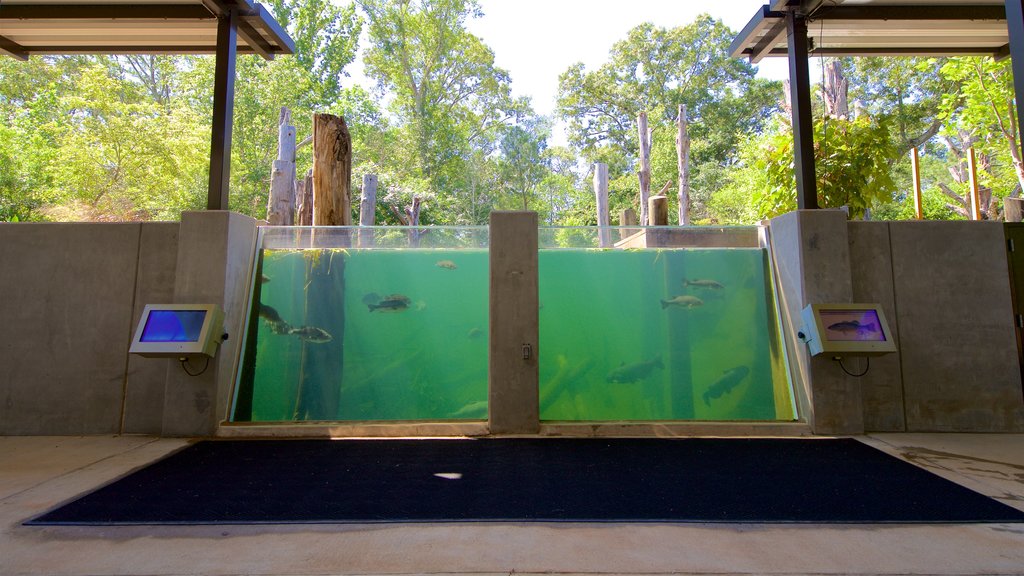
xmin=0 ymin=211 xmax=256 ymax=436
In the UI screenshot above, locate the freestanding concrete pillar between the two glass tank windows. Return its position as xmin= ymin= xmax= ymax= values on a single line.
xmin=487 ymin=212 xmax=540 ymax=435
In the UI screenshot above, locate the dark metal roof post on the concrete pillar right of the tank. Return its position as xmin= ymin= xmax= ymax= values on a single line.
xmin=785 ymin=10 xmax=818 ymax=210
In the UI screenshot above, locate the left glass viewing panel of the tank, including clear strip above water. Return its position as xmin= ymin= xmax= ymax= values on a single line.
xmin=231 ymin=227 xmax=488 ymax=422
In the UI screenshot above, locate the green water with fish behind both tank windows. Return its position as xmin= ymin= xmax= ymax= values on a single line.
xmin=232 ymin=241 xmax=795 ymax=422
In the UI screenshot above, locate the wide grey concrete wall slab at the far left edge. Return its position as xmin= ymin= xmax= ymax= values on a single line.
xmin=0 ymin=223 xmax=141 ymax=435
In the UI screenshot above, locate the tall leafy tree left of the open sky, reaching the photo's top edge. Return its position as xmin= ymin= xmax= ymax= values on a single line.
xmin=358 ymin=0 xmax=528 ymax=222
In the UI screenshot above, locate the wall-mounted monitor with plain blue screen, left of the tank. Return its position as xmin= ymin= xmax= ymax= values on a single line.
xmin=128 ymin=304 xmax=224 ymax=358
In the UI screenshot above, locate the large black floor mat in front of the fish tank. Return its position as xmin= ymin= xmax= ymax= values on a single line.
xmin=27 ymin=439 xmax=1024 ymax=525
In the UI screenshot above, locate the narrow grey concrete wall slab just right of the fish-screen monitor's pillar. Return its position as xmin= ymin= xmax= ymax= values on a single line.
xmin=848 ymin=221 xmax=906 ymax=431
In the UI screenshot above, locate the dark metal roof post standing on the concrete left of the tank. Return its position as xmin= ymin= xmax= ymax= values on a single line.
xmin=206 ymin=9 xmax=239 ymax=210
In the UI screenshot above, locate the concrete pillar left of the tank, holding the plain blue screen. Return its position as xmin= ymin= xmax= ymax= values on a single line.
xmin=163 ymin=210 xmax=256 ymax=437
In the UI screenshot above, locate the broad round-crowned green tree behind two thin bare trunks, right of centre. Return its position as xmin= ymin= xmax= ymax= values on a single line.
xmin=557 ymin=14 xmax=779 ymax=219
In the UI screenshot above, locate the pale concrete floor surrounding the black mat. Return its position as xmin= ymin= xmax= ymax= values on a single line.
xmin=0 ymin=434 xmax=1024 ymax=575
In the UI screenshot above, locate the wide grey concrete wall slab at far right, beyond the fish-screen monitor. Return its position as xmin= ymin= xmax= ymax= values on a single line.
xmin=890 ymin=221 xmax=1024 ymax=431
